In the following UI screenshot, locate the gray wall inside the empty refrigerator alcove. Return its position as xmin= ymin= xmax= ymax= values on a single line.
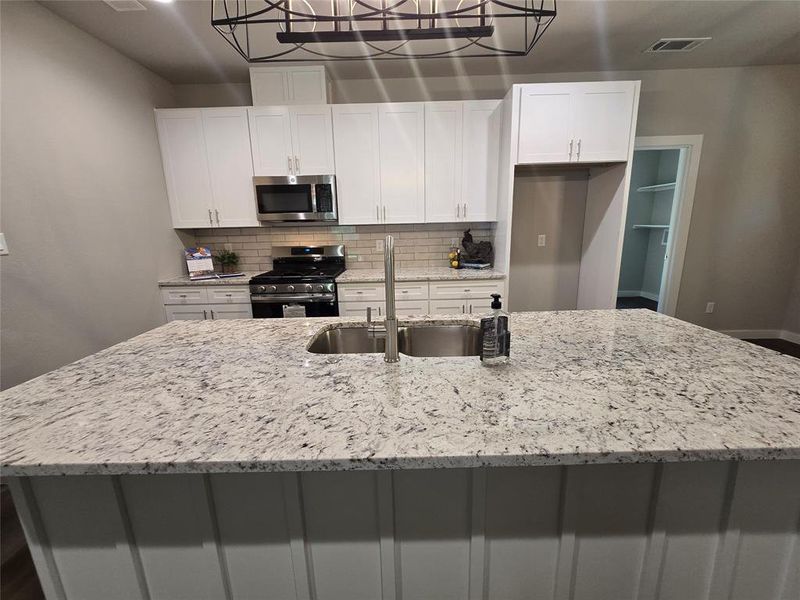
xmin=508 ymin=167 xmax=589 ymax=311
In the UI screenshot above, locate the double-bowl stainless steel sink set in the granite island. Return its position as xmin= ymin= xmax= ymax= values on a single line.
xmin=308 ymin=324 xmax=481 ymax=356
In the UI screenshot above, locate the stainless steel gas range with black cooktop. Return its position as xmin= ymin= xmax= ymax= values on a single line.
xmin=250 ymin=245 xmax=345 ymax=319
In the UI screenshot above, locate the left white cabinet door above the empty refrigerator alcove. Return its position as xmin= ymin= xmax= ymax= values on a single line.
xmin=517 ymin=83 xmax=575 ymax=164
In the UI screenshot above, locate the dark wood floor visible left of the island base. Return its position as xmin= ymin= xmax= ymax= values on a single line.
xmin=0 ymin=485 xmax=44 ymax=600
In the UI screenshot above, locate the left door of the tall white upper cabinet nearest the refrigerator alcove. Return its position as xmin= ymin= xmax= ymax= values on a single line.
xmin=425 ymin=102 xmax=464 ymax=223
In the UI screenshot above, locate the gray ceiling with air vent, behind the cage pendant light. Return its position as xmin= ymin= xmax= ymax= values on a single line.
xmin=41 ymin=0 xmax=800 ymax=83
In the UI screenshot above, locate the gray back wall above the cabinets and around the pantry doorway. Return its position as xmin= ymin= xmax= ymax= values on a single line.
xmin=176 ymin=65 xmax=800 ymax=336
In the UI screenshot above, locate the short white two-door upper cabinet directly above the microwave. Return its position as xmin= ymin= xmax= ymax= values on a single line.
xmin=248 ymin=104 xmax=336 ymax=176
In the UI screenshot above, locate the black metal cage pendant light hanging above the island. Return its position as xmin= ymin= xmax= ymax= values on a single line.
xmin=216 ymin=0 xmax=556 ymax=63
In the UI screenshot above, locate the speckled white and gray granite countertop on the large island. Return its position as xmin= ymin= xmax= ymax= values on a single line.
xmin=0 ymin=310 xmax=800 ymax=475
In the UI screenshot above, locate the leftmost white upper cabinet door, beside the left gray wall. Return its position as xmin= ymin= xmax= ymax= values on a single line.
xmin=156 ymin=109 xmax=214 ymax=228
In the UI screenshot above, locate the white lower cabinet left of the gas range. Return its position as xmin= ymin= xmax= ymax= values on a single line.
xmin=161 ymin=285 xmax=253 ymax=322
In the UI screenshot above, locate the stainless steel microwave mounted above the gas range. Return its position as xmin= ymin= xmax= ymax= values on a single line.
xmin=253 ymin=175 xmax=338 ymax=222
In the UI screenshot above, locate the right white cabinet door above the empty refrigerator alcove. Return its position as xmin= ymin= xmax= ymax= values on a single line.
xmin=573 ymin=81 xmax=636 ymax=162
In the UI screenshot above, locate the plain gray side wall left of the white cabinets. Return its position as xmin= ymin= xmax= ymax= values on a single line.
xmin=0 ymin=2 xmax=181 ymax=388
